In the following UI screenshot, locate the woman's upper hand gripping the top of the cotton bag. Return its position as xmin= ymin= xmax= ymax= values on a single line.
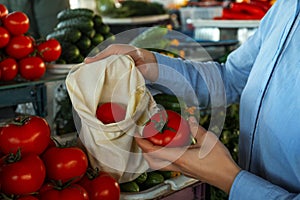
xmin=84 ymin=44 xmax=158 ymax=82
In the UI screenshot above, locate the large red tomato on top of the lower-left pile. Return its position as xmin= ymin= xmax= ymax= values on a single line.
xmin=0 ymin=116 xmax=51 ymax=155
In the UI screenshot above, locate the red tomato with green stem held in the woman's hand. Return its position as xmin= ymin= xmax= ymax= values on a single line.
xmin=143 ymin=110 xmax=191 ymax=147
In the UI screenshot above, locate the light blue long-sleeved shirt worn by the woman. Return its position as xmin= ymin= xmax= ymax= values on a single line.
xmin=152 ymin=0 xmax=300 ymax=200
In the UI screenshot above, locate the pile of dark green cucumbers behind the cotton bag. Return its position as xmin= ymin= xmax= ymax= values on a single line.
xmin=47 ymin=8 xmax=114 ymax=64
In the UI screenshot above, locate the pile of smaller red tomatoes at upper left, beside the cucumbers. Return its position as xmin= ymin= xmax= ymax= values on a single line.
xmin=0 ymin=4 xmax=62 ymax=81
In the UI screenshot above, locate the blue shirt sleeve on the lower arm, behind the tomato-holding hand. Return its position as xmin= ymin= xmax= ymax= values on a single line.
xmin=229 ymin=170 xmax=300 ymax=200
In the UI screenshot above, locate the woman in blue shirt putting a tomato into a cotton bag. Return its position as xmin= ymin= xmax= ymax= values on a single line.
xmin=85 ymin=0 xmax=300 ymax=199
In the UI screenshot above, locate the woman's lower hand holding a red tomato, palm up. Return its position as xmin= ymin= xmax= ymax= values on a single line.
xmin=135 ymin=117 xmax=241 ymax=193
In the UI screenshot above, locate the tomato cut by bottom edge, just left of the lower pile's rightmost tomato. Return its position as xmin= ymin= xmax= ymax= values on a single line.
xmin=39 ymin=184 xmax=89 ymax=200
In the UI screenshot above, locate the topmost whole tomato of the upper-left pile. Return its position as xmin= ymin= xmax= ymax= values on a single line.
xmin=3 ymin=11 xmax=29 ymax=35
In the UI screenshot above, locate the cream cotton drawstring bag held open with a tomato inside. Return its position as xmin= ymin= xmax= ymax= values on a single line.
xmin=66 ymin=55 xmax=156 ymax=183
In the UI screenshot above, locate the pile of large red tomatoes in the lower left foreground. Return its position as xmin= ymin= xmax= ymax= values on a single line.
xmin=0 ymin=116 xmax=120 ymax=200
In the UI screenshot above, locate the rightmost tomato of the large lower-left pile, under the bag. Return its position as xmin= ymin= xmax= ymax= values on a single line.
xmin=78 ymin=170 xmax=120 ymax=200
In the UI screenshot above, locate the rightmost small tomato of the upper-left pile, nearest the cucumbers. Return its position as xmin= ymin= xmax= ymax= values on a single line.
xmin=37 ymin=38 xmax=62 ymax=62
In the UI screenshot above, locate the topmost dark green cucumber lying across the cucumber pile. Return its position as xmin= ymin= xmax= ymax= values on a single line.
xmin=56 ymin=8 xmax=94 ymax=21
